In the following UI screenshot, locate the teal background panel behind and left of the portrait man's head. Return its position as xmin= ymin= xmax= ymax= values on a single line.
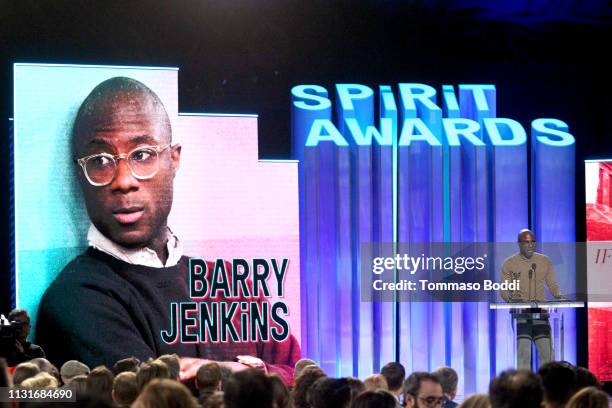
xmin=14 ymin=64 xmax=178 ymax=332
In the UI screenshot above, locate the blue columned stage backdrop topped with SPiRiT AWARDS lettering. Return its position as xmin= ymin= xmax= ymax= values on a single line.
xmin=292 ymin=84 xmax=576 ymax=395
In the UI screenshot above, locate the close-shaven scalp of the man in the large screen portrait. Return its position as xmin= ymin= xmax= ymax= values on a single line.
xmin=72 ymin=77 xmax=172 ymax=157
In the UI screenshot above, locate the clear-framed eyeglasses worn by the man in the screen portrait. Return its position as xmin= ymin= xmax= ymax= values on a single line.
xmin=76 ymin=144 xmax=172 ymax=187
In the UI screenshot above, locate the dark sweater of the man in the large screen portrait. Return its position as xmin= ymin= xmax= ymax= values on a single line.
xmin=36 ymin=248 xmax=300 ymax=380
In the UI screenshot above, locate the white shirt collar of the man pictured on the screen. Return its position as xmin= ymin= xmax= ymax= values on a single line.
xmin=87 ymin=224 xmax=183 ymax=268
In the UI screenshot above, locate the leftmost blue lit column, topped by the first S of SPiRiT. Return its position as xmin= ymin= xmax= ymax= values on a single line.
xmin=291 ymin=85 xmax=337 ymax=372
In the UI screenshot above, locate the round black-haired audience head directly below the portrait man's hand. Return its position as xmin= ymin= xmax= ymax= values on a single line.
xmin=224 ymin=368 xmax=273 ymax=408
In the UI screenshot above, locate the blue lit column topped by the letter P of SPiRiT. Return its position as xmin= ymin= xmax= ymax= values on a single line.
xmin=336 ymin=84 xmax=375 ymax=377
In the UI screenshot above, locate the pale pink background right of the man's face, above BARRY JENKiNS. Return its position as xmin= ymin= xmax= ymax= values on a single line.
xmin=169 ymin=115 xmax=300 ymax=341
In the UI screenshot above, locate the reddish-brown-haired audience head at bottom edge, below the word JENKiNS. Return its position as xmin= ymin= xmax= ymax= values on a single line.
xmin=132 ymin=378 xmax=197 ymax=408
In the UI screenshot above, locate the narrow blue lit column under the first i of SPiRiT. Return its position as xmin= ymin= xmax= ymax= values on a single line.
xmin=373 ymin=86 xmax=397 ymax=366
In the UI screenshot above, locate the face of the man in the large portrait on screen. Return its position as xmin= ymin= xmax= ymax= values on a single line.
xmin=73 ymin=92 xmax=180 ymax=247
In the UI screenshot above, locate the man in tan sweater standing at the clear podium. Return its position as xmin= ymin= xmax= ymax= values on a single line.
xmin=501 ymin=229 xmax=565 ymax=369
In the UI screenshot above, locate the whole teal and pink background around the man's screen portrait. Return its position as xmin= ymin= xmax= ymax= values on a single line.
xmin=14 ymin=64 xmax=301 ymax=339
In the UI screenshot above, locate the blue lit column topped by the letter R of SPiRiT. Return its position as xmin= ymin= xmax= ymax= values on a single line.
xmin=397 ymin=84 xmax=445 ymax=371
